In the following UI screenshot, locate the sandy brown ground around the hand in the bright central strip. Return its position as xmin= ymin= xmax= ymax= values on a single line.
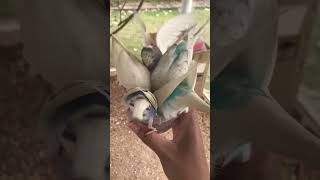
xmin=110 ymin=78 xmax=210 ymax=180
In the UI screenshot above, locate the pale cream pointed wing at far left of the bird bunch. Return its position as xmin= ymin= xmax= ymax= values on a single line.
xmin=111 ymin=36 xmax=151 ymax=90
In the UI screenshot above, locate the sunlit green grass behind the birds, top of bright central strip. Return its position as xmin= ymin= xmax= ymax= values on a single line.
xmin=110 ymin=8 xmax=210 ymax=57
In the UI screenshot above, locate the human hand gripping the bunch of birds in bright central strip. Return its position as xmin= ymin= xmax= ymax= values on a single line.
xmin=128 ymin=111 xmax=210 ymax=180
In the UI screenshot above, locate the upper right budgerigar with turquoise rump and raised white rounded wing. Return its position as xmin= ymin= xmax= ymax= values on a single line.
xmin=151 ymin=14 xmax=209 ymax=90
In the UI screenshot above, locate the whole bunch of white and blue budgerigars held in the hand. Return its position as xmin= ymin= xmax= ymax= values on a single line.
xmin=111 ymin=13 xmax=210 ymax=131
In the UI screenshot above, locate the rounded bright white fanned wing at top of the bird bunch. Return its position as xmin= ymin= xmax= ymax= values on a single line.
xmin=156 ymin=14 xmax=196 ymax=54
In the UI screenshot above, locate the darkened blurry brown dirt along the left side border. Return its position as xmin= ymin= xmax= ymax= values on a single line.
xmin=0 ymin=44 xmax=56 ymax=180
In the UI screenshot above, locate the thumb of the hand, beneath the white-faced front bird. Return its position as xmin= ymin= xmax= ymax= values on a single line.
xmin=128 ymin=121 xmax=170 ymax=156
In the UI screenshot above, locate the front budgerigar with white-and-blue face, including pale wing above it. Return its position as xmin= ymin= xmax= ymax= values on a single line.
xmin=111 ymin=36 xmax=157 ymax=127
